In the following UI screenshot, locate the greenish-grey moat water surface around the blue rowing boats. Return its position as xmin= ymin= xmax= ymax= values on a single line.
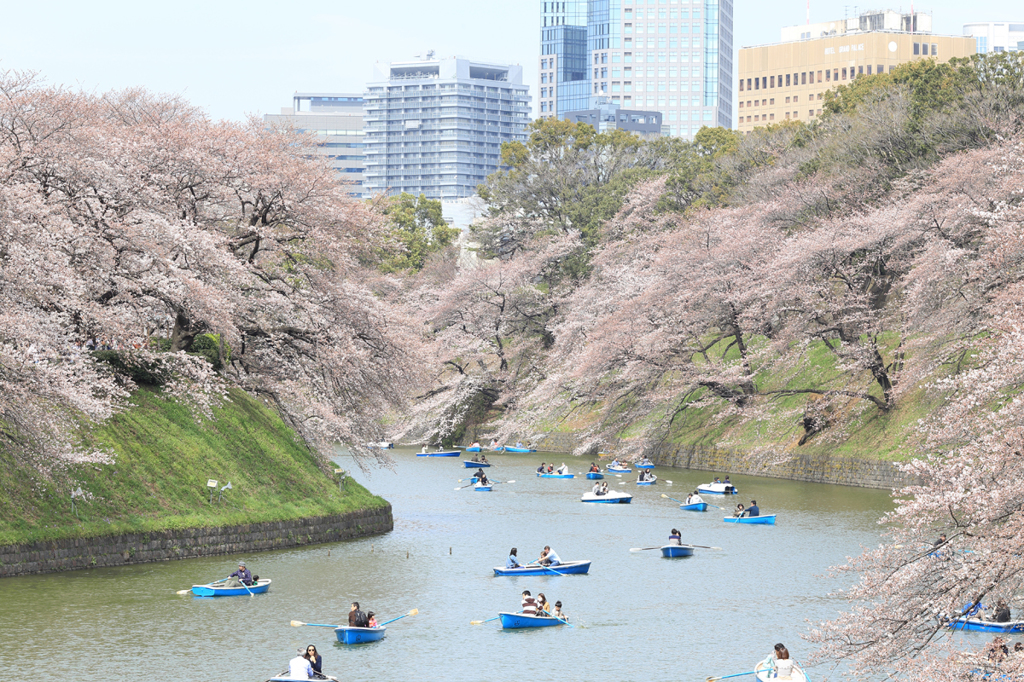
xmin=0 ymin=451 xmax=891 ymax=682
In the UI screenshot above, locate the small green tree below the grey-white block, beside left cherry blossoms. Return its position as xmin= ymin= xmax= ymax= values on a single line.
xmin=377 ymin=191 xmax=459 ymax=272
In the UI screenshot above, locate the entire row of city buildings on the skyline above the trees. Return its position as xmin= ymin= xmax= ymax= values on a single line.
xmin=265 ymin=9 xmax=1024 ymax=204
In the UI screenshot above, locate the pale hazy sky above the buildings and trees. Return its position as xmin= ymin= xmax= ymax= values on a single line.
xmin=0 ymin=0 xmax=1024 ymax=120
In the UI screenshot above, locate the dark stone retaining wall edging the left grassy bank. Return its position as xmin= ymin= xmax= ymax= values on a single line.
xmin=0 ymin=505 xmax=394 ymax=578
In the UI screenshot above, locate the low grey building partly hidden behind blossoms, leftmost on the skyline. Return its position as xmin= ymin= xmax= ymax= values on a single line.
xmin=263 ymin=92 xmax=364 ymax=197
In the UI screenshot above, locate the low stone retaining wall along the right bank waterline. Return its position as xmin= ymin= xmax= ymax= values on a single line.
xmin=497 ymin=433 xmax=914 ymax=488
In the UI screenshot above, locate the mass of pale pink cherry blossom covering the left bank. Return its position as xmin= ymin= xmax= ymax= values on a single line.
xmin=0 ymin=73 xmax=419 ymax=471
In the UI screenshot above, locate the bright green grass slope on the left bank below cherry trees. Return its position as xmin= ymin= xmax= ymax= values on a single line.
xmin=0 ymin=389 xmax=387 ymax=545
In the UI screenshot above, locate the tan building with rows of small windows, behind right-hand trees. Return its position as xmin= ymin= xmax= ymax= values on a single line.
xmin=736 ymin=11 xmax=975 ymax=132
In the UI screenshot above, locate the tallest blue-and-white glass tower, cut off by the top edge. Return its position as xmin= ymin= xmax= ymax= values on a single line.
xmin=540 ymin=0 xmax=733 ymax=138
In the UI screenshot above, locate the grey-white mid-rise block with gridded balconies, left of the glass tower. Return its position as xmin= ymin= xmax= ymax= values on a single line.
xmin=364 ymin=52 xmax=529 ymax=200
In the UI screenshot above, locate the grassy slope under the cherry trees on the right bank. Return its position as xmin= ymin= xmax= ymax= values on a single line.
xmin=546 ymin=335 xmax=941 ymax=461
